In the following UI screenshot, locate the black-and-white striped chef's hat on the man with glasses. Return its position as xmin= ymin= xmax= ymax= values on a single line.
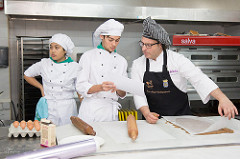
xmin=142 ymin=17 xmax=171 ymax=47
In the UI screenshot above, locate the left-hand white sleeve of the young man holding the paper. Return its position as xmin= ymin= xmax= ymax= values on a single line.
xmin=76 ymin=54 xmax=93 ymax=97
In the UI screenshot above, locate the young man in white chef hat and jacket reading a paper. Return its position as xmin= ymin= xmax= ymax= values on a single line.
xmin=76 ymin=19 xmax=127 ymax=122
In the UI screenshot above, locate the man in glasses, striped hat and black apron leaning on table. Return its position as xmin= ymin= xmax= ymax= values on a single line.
xmin=131 ymin=17 xmax=238 ymax=123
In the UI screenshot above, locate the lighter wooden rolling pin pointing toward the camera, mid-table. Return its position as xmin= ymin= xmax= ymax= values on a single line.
xmin=127 ymin=114 xmax=138 ymax=141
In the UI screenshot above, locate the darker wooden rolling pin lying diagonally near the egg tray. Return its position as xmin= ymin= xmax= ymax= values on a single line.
xmin=70 ymin=116 xmax=96 ymax=136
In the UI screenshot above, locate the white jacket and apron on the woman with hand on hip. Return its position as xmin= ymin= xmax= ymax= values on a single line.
xmin=24 ymin=58 xmax=79 ymax=125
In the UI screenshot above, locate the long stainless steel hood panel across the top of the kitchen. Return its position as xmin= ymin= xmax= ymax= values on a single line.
xmin=5 ymin=0 xmax=240 ymax=22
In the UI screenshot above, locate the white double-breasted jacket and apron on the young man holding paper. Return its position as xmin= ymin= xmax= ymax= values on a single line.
xmin=76 ymin=46 xmax=127 ymax=122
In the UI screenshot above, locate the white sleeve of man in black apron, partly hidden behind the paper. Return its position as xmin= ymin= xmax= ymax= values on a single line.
xmin=131 ymin=61 xmax=148 ymax=109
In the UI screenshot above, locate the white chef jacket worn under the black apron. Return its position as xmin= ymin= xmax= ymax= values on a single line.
xmin=131 ymin=50 xmax=218 ymax=109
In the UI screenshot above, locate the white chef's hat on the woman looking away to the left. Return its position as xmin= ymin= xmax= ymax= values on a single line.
xmin=49 ymin=33 xmax=75 ymax=56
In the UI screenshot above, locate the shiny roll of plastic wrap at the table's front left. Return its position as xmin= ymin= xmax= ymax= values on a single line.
xmin=7 ymin=139 xmax=97 ymax=159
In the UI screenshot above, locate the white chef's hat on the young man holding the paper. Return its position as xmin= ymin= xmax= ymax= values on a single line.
xmin=93 ymin=19 xmax=124 ymax=47
